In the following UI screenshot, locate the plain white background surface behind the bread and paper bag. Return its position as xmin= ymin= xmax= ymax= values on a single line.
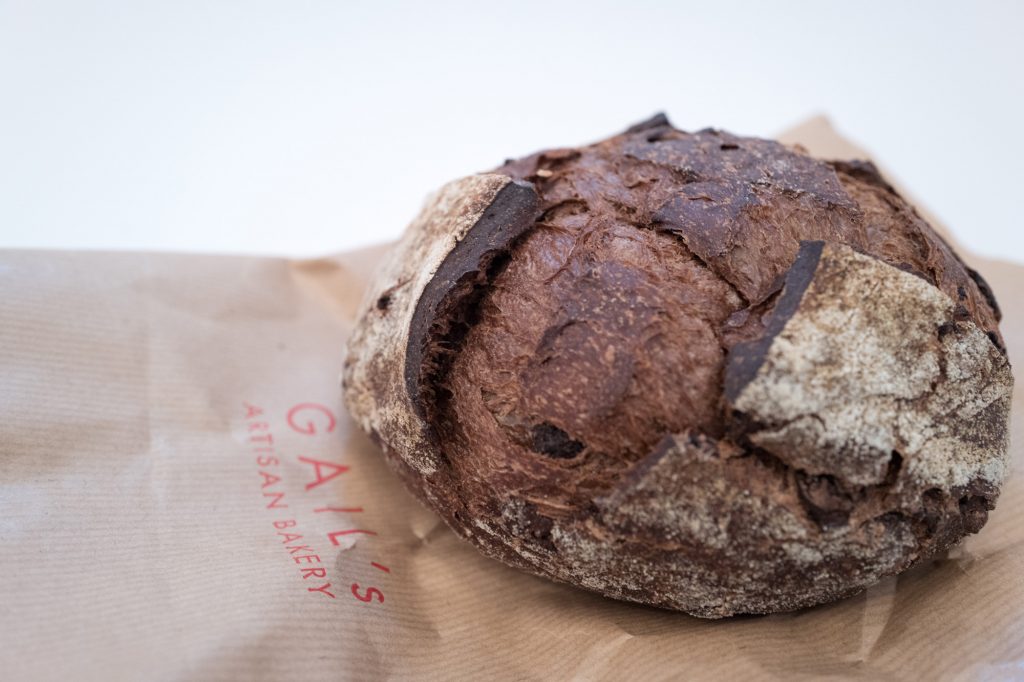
xmin=0 ymin=0 xmax=1024 ymax=261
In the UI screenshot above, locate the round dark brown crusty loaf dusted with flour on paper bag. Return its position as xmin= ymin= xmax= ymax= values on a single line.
xmin=343 ymin=116 xmax=1013 ymax=617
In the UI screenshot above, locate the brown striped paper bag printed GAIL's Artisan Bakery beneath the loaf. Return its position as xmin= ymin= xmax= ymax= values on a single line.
xmin=0 ymin=120 xmax=1024 ymax=680
